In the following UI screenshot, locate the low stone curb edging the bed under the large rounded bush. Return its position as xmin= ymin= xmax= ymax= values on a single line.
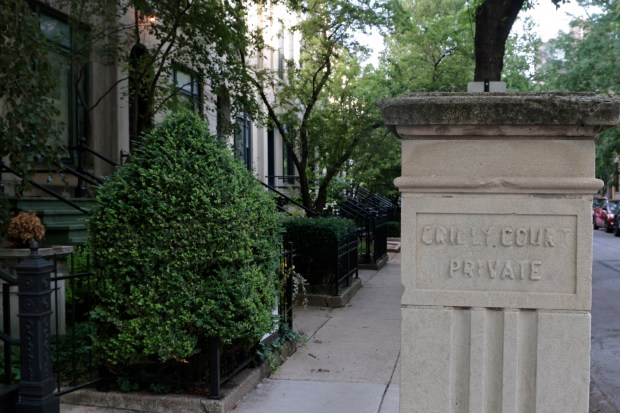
xmin=60 ymin=342 xmax=297 ymax=413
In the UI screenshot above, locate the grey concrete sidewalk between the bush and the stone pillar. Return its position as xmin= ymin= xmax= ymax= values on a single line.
xmin=233 ymin=255 xmax=402 ymax=413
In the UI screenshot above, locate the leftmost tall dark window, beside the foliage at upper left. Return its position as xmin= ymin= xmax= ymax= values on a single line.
xmin=39 ymin=10 xmax=88 ymax=154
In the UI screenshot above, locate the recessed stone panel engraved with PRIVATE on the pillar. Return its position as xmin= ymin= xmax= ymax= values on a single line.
xmin=415 ymin=213 xmax=577 ymax=294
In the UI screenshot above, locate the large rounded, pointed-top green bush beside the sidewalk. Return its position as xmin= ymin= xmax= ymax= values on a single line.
xmin=90 ymin=112 xmax=281 ymax=370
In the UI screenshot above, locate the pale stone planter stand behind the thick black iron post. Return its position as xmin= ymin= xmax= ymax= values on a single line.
xmin=0 ymin=245 xmax=74 ymax=338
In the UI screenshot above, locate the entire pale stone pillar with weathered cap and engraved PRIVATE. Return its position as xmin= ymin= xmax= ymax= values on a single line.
xmin=382 ymin=93 xmax=620 ymax=413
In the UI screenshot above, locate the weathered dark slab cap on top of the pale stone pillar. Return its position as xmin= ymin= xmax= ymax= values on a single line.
xmin=379 ymin=93 xmax=620 ymax=130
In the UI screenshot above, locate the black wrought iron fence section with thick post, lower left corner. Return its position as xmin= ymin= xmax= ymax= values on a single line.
xmin=0 ymin=245 xmax=100 ymax=412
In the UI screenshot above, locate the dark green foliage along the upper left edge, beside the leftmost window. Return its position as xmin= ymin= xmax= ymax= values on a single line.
xmin=0 ymin=0 xmax=64 ymax=177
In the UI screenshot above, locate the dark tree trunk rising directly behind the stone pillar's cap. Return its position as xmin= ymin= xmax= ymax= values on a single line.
xmin=474 ymin=0 xmax=526 ymax=82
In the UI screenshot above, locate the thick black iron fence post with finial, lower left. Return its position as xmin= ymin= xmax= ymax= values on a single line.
xmin=15 ymin=242 xmax=60 ymax=413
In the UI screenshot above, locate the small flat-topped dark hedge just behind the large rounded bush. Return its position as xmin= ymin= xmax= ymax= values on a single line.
xmin=283 ymin=217 xmax=357 ymax=293
